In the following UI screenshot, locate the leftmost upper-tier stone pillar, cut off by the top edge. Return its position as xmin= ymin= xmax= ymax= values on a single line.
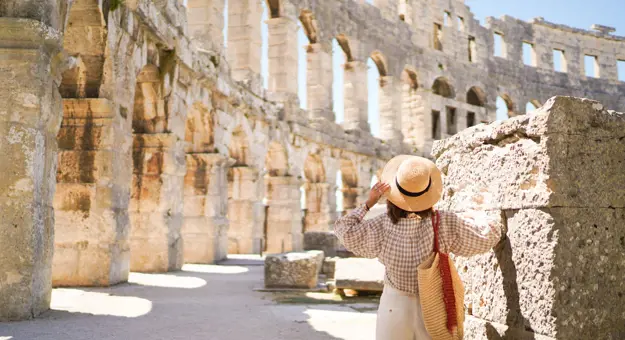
xmin=187 ymin=0 xmax=225 ymax=54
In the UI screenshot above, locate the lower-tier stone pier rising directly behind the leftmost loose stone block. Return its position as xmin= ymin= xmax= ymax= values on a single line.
xmin=265 ymin=176 xmax=303 ymax=253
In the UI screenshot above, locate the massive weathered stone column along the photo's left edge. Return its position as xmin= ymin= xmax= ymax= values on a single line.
xmin=0 ymin=0 xmax=66 ymax=321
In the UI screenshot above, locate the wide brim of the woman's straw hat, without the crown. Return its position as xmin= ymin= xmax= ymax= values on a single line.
xmin=380 ymin=155 xmax=443 ymax=212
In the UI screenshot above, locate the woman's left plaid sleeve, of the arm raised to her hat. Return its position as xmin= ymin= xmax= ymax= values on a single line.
xmin=334 ymin=205 xmax=386 ymax=258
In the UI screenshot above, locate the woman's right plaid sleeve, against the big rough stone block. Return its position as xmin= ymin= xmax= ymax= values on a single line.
xmin=441 ymin=212 xmax=501 ymax=257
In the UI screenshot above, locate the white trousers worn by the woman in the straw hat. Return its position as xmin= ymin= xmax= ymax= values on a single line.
xmin=375 ymin=285 xmax=432 ymax=340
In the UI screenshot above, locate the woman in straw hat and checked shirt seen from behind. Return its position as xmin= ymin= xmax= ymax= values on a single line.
xmin=334 ymin=155 xmax=501 ymax=340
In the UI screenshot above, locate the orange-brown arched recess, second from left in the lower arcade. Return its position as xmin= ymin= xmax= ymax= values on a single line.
xmin=132 ymin=64 xmax=167 ymax=133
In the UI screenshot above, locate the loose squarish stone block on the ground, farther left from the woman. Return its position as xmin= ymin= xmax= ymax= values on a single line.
xmin=265 ymin=250 xmax=324 ymax=288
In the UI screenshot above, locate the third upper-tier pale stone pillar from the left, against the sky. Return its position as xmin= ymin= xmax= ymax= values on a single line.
xmin=267 ymin=17 xmax=298 ymax=95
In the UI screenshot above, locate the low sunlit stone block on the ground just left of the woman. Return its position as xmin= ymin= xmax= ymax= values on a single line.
xmin=334 ymin=258 xmax=384 ymax=292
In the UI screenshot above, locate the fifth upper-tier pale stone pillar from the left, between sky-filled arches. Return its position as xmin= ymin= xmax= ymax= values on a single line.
xmin=343 ymin=60 xmax=370 ymax=132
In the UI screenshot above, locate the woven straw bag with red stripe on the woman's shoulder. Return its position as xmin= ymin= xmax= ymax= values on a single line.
xmin=417 ymin=211 xmax=464 ymax=340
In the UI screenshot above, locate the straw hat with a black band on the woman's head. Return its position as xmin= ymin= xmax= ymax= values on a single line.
xmin=381 ymin=155 xmax=443 ymax=212
